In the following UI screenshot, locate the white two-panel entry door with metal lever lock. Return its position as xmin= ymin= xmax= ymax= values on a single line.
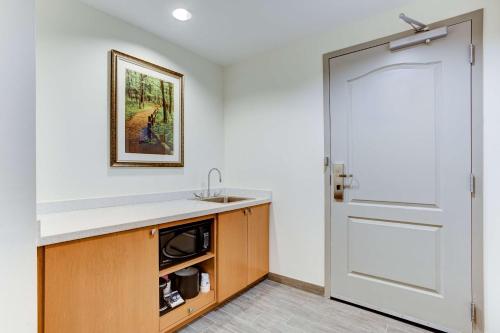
xmin=330 ymin=22 xmax=472 ymax=332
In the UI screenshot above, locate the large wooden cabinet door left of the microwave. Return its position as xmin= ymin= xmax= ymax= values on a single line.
xmin=44 ymin=228 xmax=159 ymax=333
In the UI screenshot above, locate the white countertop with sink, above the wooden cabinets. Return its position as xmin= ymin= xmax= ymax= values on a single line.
xmin=38 ymin=196 xmax=271 ymax=246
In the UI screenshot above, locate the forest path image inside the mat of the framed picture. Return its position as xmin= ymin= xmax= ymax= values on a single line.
xmin=125 ymin=69 xmax=174 ymax=155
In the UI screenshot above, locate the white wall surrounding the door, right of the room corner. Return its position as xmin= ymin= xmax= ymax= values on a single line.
xmin=224 ymin=0 xmax=500 ymax=333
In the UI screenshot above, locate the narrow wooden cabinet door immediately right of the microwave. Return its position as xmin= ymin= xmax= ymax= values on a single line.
xmin=217 ymin=210 xmax=247 ymax=302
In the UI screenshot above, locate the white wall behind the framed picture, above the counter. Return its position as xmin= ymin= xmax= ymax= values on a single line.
xmin=36 ymin=0 xmax=224 ymax=202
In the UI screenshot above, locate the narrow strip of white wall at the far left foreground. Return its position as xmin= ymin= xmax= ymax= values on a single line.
xmin=0 ymin=0 xmax=38 ymax=333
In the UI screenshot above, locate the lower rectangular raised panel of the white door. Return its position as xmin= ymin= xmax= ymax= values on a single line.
xmin=348 ymin=218 xmax=441 ymax=293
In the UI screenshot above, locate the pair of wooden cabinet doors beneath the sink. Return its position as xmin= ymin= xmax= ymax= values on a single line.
xmin=217 ymin=205 xmax=269 ymax=302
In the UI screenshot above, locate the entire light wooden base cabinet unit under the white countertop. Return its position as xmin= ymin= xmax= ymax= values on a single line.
xmin=38 ymin=204 xmax=269 ymax=333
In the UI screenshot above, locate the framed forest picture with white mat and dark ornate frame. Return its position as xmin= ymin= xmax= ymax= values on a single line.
xmin=110 ymin=50 xmax=184 ymax=167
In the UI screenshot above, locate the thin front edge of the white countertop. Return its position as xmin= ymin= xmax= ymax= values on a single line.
xmin=37 ymin=198 xmax=272 ymax=247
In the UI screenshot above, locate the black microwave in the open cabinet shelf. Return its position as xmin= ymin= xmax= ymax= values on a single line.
xmin=159 ymin=219 xmax=213 ymax=269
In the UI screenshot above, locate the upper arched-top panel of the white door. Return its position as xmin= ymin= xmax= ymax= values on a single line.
xmin=348 ymin=63 xmax=441 ymax=204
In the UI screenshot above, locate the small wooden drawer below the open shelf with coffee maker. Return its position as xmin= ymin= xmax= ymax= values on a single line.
xmin=160 ymin=290 xmax=215 ymax=332
